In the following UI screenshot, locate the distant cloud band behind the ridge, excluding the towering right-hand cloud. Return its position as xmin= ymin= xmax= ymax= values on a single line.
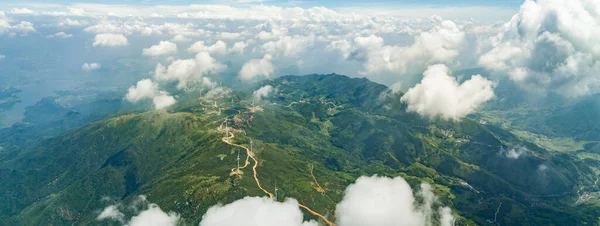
xmin=0 ymin=4 xmax=508 ymax=103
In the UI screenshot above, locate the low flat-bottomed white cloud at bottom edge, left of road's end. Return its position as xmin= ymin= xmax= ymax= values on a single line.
xmin=200 ymin=197 xmax=318 ymax=226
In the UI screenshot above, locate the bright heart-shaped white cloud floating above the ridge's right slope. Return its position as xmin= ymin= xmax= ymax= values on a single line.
xmin=401 ymin=64 xmax=495 ymax=120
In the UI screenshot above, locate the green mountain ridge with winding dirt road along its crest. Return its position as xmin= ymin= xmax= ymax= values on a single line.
xmin=0 ymin=74 xmax=600 ymax=225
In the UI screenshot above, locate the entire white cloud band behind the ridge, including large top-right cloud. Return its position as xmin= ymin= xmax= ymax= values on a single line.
xmin=7 ymin=0 xmax=600 ymax=120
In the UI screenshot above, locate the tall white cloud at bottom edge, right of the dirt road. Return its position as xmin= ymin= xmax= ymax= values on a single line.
xmin=336 ymin=176 xmax=454 ymax=226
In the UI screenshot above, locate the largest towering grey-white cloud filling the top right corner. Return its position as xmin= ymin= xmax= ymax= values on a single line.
xmin=479 ymin=0 xmax=600 ymax=97
